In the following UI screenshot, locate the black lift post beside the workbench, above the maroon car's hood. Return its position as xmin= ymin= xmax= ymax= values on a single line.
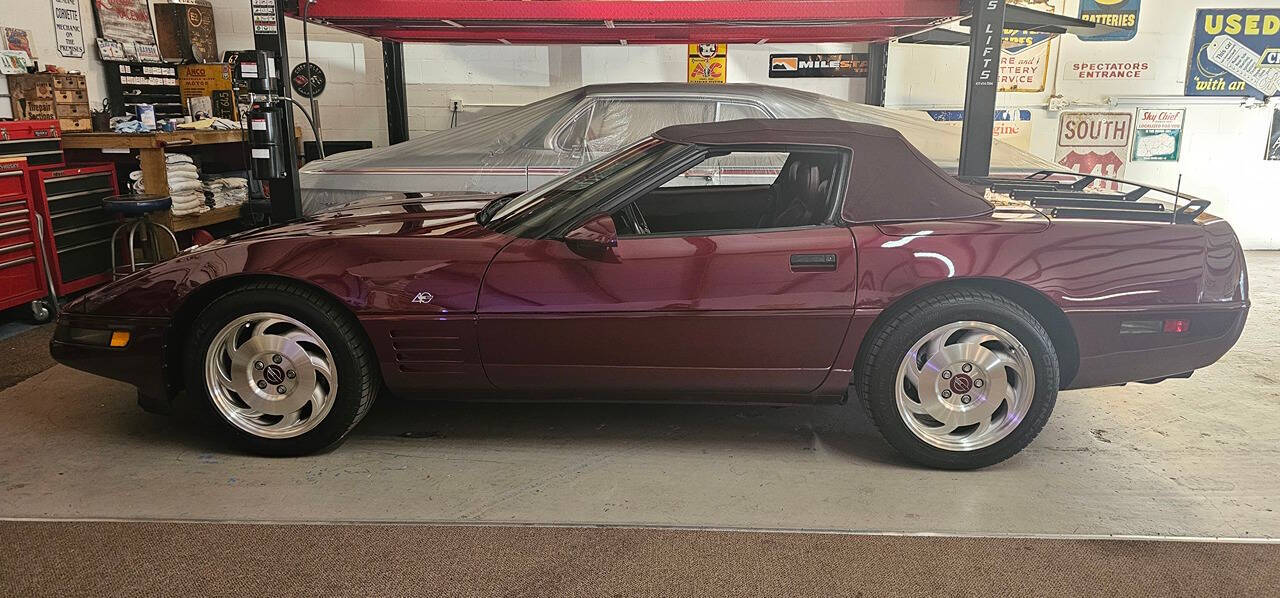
xmin=254 ymin=1 xmax=304 ymax=223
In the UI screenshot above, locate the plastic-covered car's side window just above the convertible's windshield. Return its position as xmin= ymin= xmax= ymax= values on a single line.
xmin=585 ymin=99 xmax=716 ymax=155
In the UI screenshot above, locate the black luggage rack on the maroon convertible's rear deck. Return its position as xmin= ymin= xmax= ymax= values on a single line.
xmin=963 ymin=170 xmax=1210 ymax=224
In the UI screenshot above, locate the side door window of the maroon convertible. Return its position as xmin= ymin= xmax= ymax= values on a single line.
xmin=613 ymin=151 xmax=842 ymax=237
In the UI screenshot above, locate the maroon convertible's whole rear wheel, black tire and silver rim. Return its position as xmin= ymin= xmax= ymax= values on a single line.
xmin=855 ymin=288 xmax=1059 ymax=469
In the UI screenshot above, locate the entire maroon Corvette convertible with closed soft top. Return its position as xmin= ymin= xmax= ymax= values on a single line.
xmin=51 ymin=119 xmax=1249 ymax=469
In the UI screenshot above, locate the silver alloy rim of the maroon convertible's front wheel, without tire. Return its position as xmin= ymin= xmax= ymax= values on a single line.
xmin=205 ymin=312 xmax=338 ymax=438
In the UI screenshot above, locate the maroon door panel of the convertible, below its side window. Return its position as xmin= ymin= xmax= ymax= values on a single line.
xmin=477 ymin=227 xmax=856 ymax=393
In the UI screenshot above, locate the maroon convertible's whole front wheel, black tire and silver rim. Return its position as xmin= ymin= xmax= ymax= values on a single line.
xmin=186 ymin=283 xmax=378 ymax=456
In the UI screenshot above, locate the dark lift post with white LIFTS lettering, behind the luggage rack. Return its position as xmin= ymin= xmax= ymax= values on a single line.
xmin=957 ymin=0 xmax=1005 ymax=177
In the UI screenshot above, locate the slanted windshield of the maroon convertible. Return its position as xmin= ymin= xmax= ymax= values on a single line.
xmin=479 ymin=137 xmax=689 ymax=236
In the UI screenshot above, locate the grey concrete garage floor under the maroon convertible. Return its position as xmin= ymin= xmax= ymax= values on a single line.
xmin=0 ymin=254 xmax=1280 ymax=538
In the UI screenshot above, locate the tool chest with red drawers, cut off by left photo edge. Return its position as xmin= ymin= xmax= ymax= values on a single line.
xmin=0 ymin=158 xmax=49 ymax=320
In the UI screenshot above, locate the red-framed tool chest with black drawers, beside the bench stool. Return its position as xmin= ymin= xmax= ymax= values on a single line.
xmin=31 ymin=164 xmax=120 ymax=296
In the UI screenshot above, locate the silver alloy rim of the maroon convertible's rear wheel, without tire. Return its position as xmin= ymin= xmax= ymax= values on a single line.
xmin=896 ymin=321 xmax=1036 ymax=451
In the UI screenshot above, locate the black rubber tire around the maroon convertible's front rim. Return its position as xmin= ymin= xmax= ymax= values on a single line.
xmin=183 ymin=282 xmax=381 ymax=457
